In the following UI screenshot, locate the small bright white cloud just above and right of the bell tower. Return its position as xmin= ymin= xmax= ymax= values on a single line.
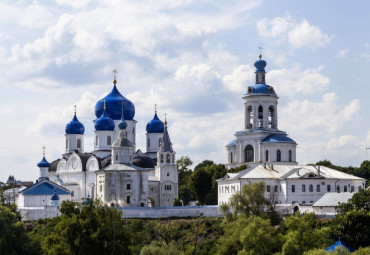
xmin=257 ymin=15 xmax=333 ymax=49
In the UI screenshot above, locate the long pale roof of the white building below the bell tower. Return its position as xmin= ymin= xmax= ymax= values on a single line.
xmin=219 ymin=165 xmax=364 ymax=180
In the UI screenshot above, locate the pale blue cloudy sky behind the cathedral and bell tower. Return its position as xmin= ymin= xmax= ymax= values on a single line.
xmin=0 ymin=0 xmax=370 ymax=181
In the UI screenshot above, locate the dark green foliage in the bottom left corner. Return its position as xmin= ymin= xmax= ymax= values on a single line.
xmin=0 ymin=205 xmax=37 ymax=255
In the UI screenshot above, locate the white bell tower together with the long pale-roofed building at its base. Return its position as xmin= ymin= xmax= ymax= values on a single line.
xmin=217 ymin=55 xmax=365 ymax=205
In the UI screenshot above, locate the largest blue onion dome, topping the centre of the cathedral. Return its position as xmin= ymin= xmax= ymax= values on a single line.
xmin=95 ymin=84 xmax=135 ymax=120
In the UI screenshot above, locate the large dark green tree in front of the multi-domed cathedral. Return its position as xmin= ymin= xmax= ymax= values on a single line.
xmin=42 ymin=201 xmax=130 ymax=254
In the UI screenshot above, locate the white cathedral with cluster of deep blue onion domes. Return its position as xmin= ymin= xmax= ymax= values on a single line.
xmin=22 ymin=71 xmax=178 ymax=207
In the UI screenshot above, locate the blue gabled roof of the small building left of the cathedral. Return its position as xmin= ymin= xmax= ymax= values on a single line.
xmin=21 ymin=180 xmax=70 ymax=196
